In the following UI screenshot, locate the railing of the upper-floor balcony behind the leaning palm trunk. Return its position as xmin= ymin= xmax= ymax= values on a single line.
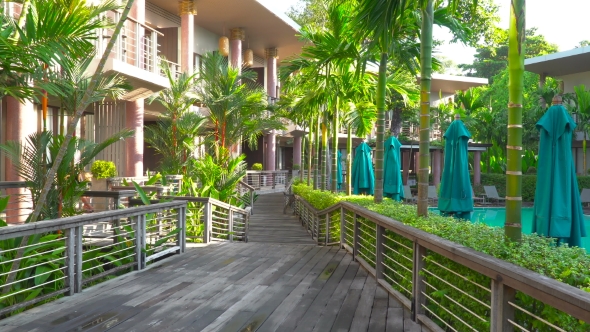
xmin=96 ymin=11 xmax=180 ymax=77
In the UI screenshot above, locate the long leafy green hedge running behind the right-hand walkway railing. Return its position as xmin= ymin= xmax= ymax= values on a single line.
xmin=293 ymin=184 xmax=590 ymax=331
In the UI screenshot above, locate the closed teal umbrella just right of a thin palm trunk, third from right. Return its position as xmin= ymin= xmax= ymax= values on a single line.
xmin=383 ymin=136 xmax=404 ymax=201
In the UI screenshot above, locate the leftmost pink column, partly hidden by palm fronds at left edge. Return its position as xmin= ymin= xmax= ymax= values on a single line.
xmin=5 ymin=97 xmax=37 ymax=224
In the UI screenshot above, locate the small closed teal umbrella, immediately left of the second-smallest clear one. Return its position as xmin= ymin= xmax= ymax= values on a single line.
xmin=352 ymin=142 xmax=375 ymax=195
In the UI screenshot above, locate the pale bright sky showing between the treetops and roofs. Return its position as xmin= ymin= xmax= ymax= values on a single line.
xmin=258 ymin=0 xmax=590 ymax=71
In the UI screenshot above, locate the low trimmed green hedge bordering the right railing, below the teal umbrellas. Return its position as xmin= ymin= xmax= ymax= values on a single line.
xmin=293 ymin=184 xmax=590 ymax=331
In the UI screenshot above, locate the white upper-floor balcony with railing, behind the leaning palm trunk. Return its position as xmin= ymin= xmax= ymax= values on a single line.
xmin=91 ymin=11 xmax=180 ymax=101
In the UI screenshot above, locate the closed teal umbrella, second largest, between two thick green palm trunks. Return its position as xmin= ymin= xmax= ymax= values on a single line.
xmin=438 ymin=119 xmax=473 ymax=219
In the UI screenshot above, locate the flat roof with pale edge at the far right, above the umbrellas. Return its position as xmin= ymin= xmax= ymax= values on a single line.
xmin=524 ymin=46 xmax=590 ymax=77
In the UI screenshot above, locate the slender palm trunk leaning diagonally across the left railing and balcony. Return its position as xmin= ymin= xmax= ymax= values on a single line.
xmin=2 ymin=0 xmax=133 ymax=294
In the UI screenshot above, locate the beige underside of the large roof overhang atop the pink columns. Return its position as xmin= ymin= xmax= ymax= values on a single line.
xmin=148 ymin=0 xmax=304 ymax=59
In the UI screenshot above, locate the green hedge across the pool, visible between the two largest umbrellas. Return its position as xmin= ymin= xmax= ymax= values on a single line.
xmin=478 ymin=173 xmax=590 ymax=202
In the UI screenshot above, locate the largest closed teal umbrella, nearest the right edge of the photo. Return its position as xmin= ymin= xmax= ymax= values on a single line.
xmin=533 ymin=105 xmax=586 ymax=247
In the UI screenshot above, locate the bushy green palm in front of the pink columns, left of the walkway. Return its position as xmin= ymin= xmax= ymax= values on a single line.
xmin=196 ymin=53 xmax=284 ymax=148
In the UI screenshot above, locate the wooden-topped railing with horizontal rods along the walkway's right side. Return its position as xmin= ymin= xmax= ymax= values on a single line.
xmin=294 ymin=196 xmax=590 ymax=331
